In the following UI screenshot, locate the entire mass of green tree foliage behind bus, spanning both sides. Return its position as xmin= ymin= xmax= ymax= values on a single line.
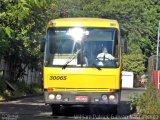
xmin=0 ymin=0 xmax=160 ymax=79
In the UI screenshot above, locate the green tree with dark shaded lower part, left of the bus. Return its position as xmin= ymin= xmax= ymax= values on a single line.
xmin=0 ymin=0 xmax=54 ymax=80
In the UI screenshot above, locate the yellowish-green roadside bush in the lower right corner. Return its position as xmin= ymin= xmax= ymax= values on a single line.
xmin=130 ymin=84 xmax=160 ymax=115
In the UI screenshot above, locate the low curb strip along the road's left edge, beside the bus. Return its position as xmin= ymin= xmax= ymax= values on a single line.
xmin=0 ymin=93 xmax=43 ymax=102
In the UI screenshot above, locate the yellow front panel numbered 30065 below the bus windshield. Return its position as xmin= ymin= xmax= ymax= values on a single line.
xmin=44 ymin=67 xmax=120 ymax=92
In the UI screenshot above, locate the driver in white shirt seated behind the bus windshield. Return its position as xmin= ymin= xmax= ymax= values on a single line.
xmin=97 ymin=47 xmax=114 ymax=61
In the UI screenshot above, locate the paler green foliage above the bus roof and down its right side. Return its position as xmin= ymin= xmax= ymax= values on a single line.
xmin=53 ymin=0 xmax=160 ymax=75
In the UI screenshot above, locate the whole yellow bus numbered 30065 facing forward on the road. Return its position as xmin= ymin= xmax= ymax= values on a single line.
xmin=41 ymin=18 xmax=122 ymax=114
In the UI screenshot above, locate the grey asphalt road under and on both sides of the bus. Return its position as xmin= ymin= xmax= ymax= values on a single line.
xmin=0 ymin=89 xmax=145 ymax=120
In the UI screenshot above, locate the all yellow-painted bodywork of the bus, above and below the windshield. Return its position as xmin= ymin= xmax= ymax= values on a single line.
xmin=43 ymin=18 xmax=121 ymax=92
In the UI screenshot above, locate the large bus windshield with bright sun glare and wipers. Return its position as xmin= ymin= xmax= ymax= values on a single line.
xmin=46 ymin=27 xmax=119 ymax=68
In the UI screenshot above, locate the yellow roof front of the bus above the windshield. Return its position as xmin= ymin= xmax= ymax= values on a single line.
xmin=47 ymin=18 xmax=119 ymax=29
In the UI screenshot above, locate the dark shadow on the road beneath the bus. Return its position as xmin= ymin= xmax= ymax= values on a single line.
xmin=38 ymin=101 xmax=135 ymax=119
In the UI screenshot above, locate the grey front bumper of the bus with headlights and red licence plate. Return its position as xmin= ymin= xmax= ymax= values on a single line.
xmin=44 ymin=91 xmax=120 ymax=105
